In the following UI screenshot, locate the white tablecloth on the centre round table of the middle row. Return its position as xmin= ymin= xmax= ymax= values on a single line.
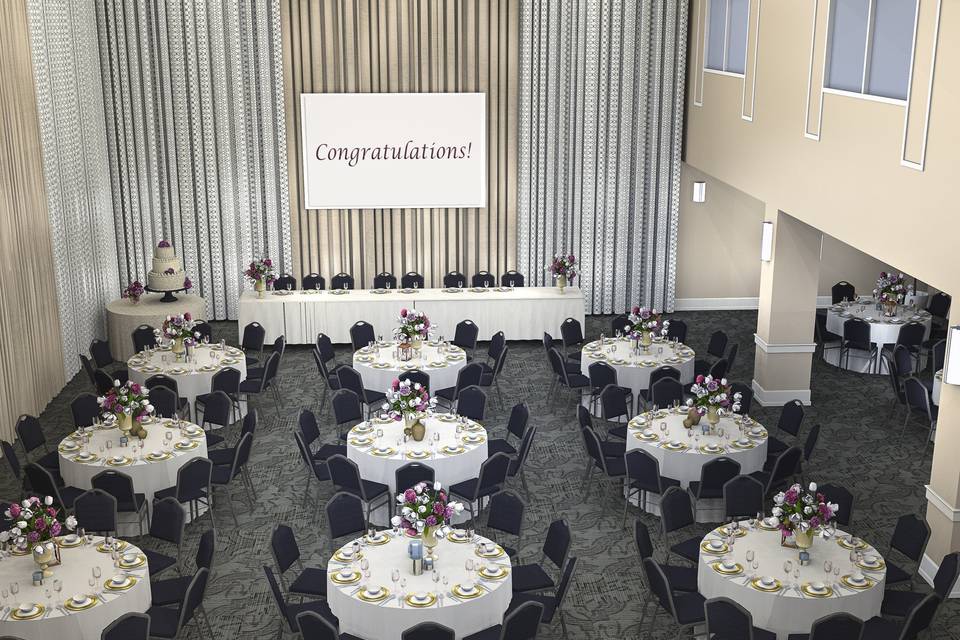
xmin=347 ymin=414 xmax=487 ymax=494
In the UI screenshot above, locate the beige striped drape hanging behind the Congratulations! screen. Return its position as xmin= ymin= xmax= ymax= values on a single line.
xmin=281 ymin=0 xmax=519 ymax=286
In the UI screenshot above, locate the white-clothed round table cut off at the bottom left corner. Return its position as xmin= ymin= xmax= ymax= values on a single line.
xmin=0 ymin=537 xmax=151 ymax=640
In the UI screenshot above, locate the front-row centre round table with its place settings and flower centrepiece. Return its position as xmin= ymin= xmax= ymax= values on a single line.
xmin=327 ymin=482 xmax=513 ymax=640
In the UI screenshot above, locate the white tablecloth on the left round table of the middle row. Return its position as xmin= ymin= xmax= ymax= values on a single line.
xmin=59 ymin=420 xmax=207 ymax=536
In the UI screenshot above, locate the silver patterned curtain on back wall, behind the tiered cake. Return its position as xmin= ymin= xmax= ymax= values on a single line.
xmin=95 ymin=0 xmax=291 ymax=319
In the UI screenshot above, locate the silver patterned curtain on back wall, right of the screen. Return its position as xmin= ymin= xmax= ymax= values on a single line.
xmin=517 ymin=0 xmax=687 ymax=313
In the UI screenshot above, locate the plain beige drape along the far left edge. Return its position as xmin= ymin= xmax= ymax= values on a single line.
xmin=0 ymin=0 xmax=64 ymax=442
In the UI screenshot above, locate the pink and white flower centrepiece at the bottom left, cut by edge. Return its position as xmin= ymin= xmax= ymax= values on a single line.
xmin=0 ymin=496 xmax=77 ymax=578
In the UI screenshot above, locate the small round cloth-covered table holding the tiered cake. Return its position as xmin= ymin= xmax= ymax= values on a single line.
xmin=107 ymin=293 xmax=207 ymax=360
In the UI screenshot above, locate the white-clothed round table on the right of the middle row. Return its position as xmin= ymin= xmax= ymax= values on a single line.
xmin=627 ymin=407 xmax=768 ymax=522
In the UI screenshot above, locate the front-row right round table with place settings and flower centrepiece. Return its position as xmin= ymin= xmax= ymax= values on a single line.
xmin=697 ymin=483 xmax=886 ymax=640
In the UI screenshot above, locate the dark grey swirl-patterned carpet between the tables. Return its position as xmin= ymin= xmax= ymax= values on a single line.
xmin=0 ymin=312 xmax=960 ymax=640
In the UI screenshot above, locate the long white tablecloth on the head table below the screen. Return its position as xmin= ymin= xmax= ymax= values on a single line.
xmin=238 ymin=287 xmax=584 ymax=344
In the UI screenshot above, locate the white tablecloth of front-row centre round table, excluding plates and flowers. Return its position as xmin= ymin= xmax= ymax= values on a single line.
xmin=327 ymin=531 xmax=513 ymax=640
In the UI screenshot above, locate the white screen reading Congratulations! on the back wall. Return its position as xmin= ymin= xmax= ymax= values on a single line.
xmin=300 ymin=93 xmax=487 ymax=209
